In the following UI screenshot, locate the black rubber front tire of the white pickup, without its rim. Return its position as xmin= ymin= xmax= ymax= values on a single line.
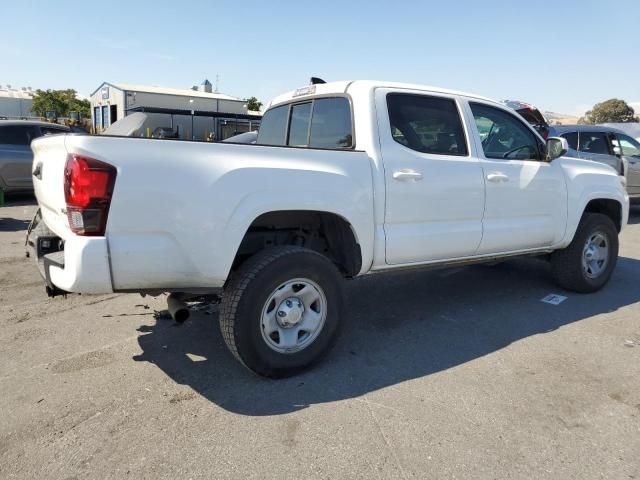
xmin=551 ymin=213 xmax=618 ymax=293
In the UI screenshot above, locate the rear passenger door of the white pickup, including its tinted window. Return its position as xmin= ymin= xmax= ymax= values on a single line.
xmin=376 ymin=89 xmax=484 ymax=265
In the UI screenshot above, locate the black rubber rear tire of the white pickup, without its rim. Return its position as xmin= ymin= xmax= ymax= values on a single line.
xmin=220 ymin=246 xmax=343 ymax=378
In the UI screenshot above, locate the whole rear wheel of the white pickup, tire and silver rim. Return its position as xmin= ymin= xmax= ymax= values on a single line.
xmin=220 ymin=246 xmax=343 ymax=378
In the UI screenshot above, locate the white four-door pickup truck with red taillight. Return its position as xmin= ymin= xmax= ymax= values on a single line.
xmin=29 ymin=81 xmax=629 ymax=377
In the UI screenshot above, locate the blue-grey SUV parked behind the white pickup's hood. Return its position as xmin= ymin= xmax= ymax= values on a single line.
xmin=551 ymin=125 xmax=640 ymax=202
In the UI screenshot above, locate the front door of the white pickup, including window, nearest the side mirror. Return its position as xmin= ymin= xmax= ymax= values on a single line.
xmin=469 ymin=102 xmax=567 ymax=254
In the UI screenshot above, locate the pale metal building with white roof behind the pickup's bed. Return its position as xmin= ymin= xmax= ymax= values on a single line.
xmin=91 ymin=80 xmax=261 ymax=140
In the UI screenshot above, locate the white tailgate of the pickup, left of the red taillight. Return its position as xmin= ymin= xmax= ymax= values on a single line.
xmin=31 ymin=135 xmax=71 ymax=238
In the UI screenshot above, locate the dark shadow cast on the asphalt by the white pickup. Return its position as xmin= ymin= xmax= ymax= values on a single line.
xmin=135 ymin=251 xmax=640 ymax=415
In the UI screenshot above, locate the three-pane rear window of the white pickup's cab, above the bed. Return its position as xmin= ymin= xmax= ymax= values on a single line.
xmin=256 ymin=97 xmax=354 ymax=150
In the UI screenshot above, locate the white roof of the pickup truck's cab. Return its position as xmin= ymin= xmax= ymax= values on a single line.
xmin=269 ymin=80 xmax=502 ymax=108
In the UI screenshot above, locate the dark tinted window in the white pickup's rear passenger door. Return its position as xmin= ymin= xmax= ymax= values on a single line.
xmin=387 ymin=93 xmax=468 ymax=156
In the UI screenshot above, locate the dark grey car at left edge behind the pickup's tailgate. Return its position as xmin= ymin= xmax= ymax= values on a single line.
xmin=0 ymin=120 xmax=71 ymax=193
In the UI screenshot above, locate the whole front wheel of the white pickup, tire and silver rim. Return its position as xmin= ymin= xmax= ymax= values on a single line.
xmin=551 ymin=213 xmax=618 ymax=293
